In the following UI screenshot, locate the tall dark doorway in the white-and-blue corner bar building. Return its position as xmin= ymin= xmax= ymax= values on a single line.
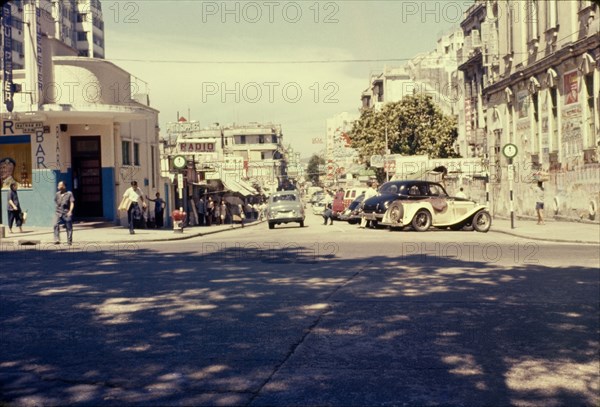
xmin=71 ymin=136 xmax=104 ymax=218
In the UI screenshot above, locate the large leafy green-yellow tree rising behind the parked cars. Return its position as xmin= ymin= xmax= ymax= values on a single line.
xmin=351 ymin=94 xmax=458 ymax=179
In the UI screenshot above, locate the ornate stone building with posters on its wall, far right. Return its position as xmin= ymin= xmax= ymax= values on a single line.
xmin=480 ymin=0 xmax=600 ymax=217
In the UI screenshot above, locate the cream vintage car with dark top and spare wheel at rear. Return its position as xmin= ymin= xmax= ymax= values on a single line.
xmin=380 ymin=181 xmax=492 ymax=232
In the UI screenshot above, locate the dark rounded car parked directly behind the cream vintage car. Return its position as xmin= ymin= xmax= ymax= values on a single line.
xmin=363 ymin=180 xmax=445 ymax=223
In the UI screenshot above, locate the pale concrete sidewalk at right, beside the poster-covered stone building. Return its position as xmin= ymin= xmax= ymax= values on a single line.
xmin=490 ymin=217 xmax=600 ymax=245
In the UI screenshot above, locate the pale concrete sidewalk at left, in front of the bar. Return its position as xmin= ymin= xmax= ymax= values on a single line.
xmin=0 ymin=221 xmax=264 ymax=244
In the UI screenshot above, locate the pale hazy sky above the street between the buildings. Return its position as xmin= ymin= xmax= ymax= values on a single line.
xmin=102 ymin=0 xmax=473 ymax=156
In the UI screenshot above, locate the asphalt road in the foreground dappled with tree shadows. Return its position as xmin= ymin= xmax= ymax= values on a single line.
xmin=0 ymin=215 xmax=600 ymax=406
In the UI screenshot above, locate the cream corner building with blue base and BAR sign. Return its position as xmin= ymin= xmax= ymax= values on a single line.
xmin=0 ymin=0 xmax=166 ymax=226
